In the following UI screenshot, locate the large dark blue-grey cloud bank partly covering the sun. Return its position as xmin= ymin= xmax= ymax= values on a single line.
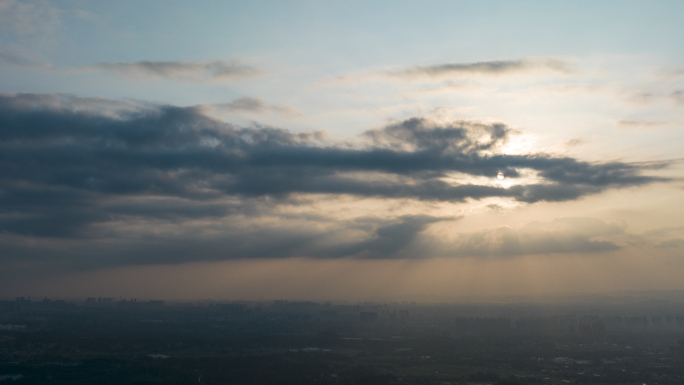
xmin=0 ymin=94 xmax=668 ymax=202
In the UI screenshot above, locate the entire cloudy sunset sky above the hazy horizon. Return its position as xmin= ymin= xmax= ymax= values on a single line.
xmin=0 ymin=0 xmax=684 ymax=301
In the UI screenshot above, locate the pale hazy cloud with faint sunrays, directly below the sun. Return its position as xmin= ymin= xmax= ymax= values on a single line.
xmin=450 ymin=218 xmax=626 ymax=257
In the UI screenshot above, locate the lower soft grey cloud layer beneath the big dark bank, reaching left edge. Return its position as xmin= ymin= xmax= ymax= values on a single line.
xmin=0 ymin=213 xmax=457 ymax=270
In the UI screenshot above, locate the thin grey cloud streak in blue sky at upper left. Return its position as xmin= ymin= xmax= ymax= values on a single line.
xmin=85 ymin=60 xmax=262 ymax=82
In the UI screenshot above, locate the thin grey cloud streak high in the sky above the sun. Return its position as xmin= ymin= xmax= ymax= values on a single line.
xmin=388 ymin=59 xmax=570 ymax=78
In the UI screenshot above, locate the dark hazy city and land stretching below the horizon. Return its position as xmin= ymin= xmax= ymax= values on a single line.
xmin=0 ymin=297 xmax=684 ymax=385
